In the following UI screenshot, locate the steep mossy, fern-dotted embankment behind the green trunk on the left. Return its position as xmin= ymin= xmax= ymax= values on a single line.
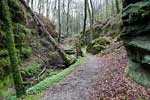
xmin=0 ymin=0 xmax=59 ymax=99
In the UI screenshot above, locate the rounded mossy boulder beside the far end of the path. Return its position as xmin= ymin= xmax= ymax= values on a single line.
xmin=87 ymin=37 xmax=110 ymax=54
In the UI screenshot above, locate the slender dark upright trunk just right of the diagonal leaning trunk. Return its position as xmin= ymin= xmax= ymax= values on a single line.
xmin=58 ymin=0 xmax=61 ymax=43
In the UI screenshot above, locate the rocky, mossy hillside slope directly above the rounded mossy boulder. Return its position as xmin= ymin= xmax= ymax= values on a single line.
xmin=81 ymin=14 xmax=122 ymax=45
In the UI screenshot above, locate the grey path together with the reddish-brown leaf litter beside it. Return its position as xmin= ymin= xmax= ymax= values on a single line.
xmin=41 ymin=47 xmax=150 ymax=100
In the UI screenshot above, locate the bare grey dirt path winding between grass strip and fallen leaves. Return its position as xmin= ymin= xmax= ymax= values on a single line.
xmin=41 ymin=55 xmax=102 ymax=100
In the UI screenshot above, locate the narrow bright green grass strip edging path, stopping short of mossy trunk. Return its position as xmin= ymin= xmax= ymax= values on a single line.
xmin=27 ymin=58 xmax=83 ymax=94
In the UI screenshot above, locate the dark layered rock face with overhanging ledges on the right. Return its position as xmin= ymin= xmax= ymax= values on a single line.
xmin=121 ymin=0 xmax=150 ymax=85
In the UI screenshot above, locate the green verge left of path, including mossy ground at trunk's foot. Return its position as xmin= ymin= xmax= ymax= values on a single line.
xmin=15 ymin=57 xmax=83 ymax=100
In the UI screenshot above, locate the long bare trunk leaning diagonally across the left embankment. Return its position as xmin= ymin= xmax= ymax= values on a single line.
xmin=19 ymin=0 xmax=71 ymax=66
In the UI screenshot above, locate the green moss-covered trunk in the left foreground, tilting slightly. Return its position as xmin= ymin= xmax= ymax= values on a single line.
xmin=0 ymin=0 xmax=25 ymax=97
